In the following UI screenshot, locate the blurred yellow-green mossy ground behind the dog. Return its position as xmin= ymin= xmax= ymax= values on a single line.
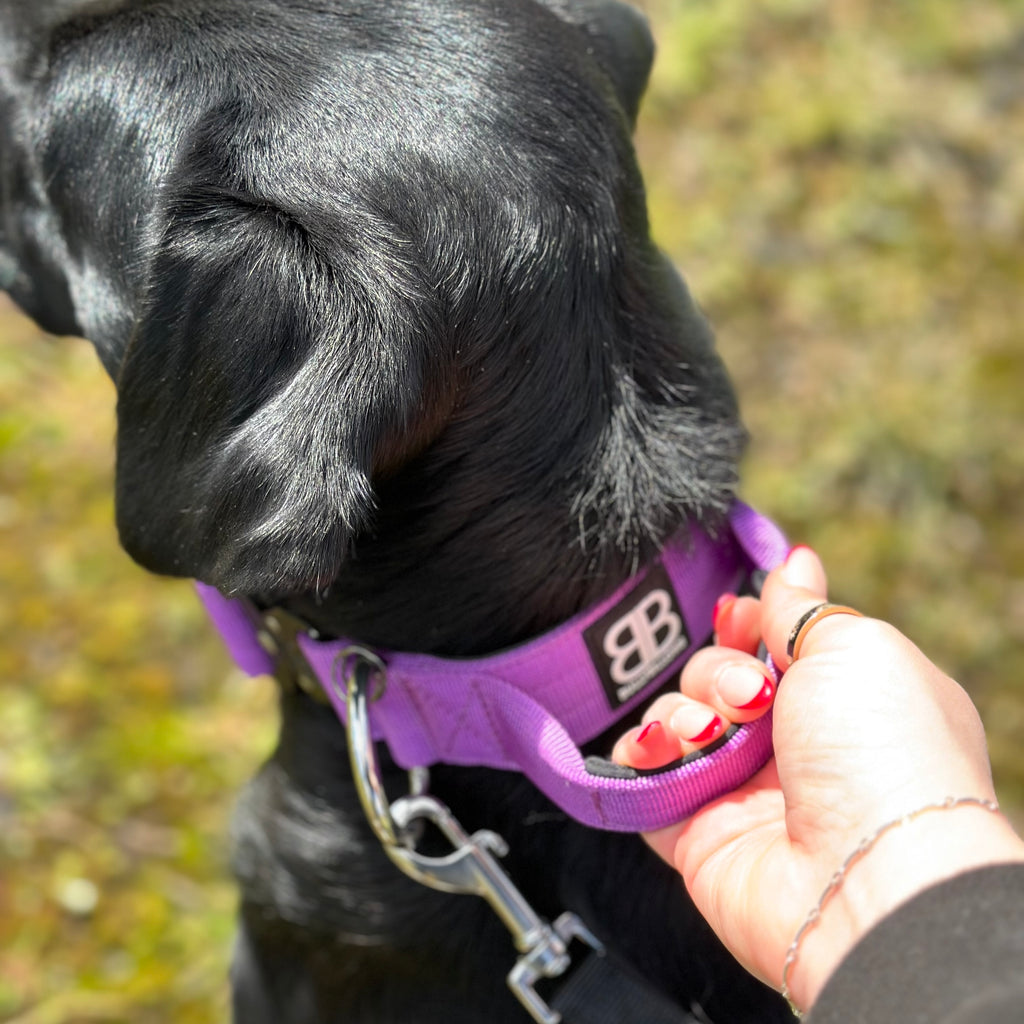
xmin=0 ymin=0 xmax=1024 ymax=1024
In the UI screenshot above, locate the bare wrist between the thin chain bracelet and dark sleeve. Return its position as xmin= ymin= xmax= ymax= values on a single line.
xmin=786 ymin=803 xmax=1024 ymax=1010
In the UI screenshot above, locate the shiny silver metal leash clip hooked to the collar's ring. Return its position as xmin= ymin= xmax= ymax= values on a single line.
xmin=333 ymin=647 xmax=604 ymax=1024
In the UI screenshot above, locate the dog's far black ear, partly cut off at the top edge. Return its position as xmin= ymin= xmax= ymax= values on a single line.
xmin=542 ymin=0 xmax=654 ymax=127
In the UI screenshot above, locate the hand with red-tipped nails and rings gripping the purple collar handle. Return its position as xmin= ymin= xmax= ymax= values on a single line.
xmin=612 ymin=548 xmax=1024 ymax=1009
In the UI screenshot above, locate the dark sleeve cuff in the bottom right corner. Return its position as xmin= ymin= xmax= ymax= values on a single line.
xmin=806 ymin=864 xmax=1024 ymax=1024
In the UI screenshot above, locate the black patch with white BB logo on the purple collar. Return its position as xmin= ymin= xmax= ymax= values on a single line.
xmin=584 ymin=565 xmax=690 ymax=707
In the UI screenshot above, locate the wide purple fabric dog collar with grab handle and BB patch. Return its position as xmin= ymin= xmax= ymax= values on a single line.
xmin=199 ymin=503 xmax=787 ymax=831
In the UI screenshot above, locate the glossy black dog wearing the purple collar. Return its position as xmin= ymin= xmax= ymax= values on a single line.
xmin=0 ymin=0 xmax=787 ymax=1024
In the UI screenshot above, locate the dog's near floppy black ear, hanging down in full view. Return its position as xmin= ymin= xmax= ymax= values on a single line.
xmin=116 ymin=175 xmax=440 ymax=595
